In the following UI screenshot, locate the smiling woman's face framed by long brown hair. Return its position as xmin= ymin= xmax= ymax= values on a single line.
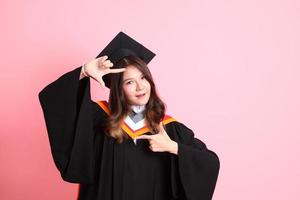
xmin=122 ymin=65 xmax=151 ymax=106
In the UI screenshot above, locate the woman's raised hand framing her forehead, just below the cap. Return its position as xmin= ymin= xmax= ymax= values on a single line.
xmin=80 ymin=56 xmax=126 ymax=87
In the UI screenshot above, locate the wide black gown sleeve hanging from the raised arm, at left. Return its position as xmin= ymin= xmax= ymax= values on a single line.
xmin=39 ymin=67 xmax=105 ymax=184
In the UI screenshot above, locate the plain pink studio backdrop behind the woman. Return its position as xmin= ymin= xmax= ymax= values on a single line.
xmin=0 ymin=0 xmax=300 ymax=200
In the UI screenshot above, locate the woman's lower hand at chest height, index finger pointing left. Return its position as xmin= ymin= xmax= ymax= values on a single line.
xmin=134 ymin=122 xmax=178 ymax=155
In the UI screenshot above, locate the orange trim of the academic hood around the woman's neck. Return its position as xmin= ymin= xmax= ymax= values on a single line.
xmin=96 ymin=101 xmax=176 ymax=139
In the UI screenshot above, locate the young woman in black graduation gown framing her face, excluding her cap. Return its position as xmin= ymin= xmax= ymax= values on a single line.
xmin=39 ymin=31 xmax=219 ymax=200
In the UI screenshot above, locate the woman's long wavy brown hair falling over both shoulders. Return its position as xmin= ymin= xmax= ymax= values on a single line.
xmin=105 ymin=56 xmax=165 ymax=143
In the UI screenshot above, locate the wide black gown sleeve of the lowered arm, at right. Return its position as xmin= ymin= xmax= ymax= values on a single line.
xmin=171 ymin=122 xmax=220 ymax=200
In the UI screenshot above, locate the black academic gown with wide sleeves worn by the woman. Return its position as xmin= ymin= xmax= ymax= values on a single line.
xmin=39 ymin=67 xmax=219 ymax=200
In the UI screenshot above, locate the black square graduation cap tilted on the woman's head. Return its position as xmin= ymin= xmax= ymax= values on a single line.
xmin=96 ymin=32 xmax=155 ymax=87
